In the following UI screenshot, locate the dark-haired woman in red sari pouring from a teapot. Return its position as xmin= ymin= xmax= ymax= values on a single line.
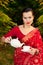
xmin=2 ymin=8 xmax=43 ymax=65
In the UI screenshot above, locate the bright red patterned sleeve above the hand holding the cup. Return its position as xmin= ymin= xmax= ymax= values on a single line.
xmin=34 ymin=30 xmax=43 ymax=50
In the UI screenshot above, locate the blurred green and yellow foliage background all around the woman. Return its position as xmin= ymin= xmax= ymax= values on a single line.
xmin=0 ymin=0 xmax=43 ymax=65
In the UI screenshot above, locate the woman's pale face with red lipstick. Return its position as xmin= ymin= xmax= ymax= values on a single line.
xmin=22 ymin=11 xmax=34 ymax=25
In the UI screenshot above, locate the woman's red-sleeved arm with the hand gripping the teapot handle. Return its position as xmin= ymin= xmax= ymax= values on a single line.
xmin=1 ymin=27 xmax=17 ymax=43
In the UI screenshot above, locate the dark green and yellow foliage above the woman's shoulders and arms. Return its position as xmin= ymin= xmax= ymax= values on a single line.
xmin=0 ymin=0 xmax=43 ymax=36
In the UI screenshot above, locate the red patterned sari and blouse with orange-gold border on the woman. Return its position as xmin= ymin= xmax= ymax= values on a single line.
xmin=5 ymin=26 xmax=43 ymax=65
